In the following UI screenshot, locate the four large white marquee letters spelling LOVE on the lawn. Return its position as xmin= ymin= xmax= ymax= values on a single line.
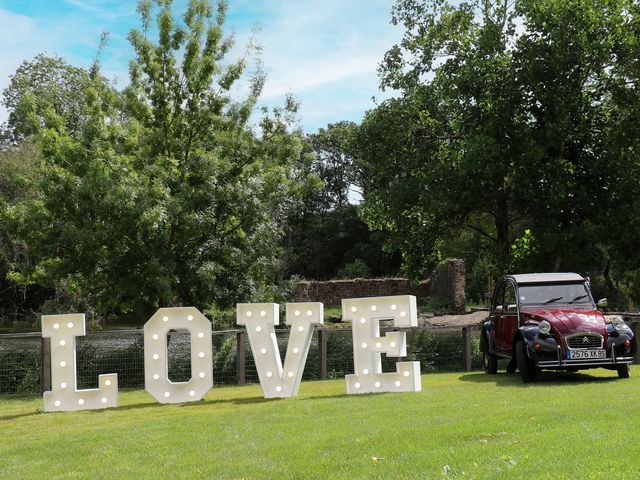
xmin=42 ymin=295 xmax=421 ymax=412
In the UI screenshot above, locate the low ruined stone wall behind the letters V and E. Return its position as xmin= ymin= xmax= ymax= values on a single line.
xmin=293 ymin=259 xmax=465 ymax=311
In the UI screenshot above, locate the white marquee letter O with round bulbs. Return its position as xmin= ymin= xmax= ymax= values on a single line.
xmin=144 ymin=307 xmax=213 ymax=403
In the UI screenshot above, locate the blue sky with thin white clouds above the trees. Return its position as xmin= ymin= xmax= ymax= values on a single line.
xmin=0 ymin=0 xmax=402 ymax=132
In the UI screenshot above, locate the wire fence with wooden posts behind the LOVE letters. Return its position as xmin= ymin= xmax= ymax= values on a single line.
xmin=0 ymin=327 xmax=483 ymax=395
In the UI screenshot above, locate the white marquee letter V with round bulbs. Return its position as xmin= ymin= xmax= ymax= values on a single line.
xmin=236 ymin=303 xmax=324 ymax=398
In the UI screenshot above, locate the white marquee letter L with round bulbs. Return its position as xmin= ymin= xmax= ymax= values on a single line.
xmin=42 ymin=313 xmax=118 ymax=412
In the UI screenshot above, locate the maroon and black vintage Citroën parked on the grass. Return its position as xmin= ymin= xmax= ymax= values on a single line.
xmin=480 ymin=273 xmax=637 ymax=382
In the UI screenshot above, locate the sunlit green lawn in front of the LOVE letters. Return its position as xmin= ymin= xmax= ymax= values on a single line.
xmin=0 ymin=367 xmax=640 ymax=480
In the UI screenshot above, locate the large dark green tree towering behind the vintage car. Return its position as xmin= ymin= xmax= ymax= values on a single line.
xmin=357 ymin=0 xmax=638 ymax=282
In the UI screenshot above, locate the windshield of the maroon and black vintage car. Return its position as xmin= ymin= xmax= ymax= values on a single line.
xmin=518 ymin=283 xmax=593 ymax=307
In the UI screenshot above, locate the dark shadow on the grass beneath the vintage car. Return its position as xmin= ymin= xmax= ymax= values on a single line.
xmin=460 ymin=371 xmax=619 ymax=388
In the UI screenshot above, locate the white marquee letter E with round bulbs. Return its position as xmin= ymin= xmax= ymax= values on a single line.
xmin=342 ymin=295 xmax=422 ymax=393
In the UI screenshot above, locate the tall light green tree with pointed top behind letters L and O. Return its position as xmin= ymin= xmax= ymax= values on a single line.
xmin=10 ymin=0 xmax=302 ymax=318
